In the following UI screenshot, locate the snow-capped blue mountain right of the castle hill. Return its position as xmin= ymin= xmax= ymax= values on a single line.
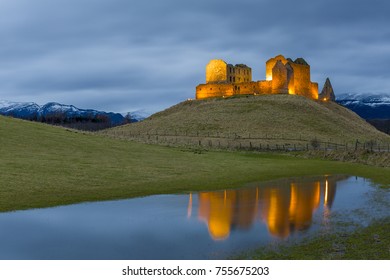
xmin=336 ymin=93 xmax=390 ymax=119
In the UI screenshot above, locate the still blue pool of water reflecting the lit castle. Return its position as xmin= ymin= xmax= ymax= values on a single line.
xmin=0 ymin=175 xmax=390 ymax=259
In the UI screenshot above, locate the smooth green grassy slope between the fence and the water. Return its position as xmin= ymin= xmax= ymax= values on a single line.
xmin=0 ymin=117 xmax=390 ymax=211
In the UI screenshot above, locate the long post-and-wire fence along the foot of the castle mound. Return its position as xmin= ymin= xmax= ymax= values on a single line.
xmin=108 ymin=131 xmax=390 ymax=152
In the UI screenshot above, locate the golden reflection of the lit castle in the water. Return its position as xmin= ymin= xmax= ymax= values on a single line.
xmin=189 ymin=176 xmax=345 ymax=240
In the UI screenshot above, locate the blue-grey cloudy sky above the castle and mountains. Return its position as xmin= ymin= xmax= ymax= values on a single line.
xmin=0 ymin=0 xmax=390 ymax=112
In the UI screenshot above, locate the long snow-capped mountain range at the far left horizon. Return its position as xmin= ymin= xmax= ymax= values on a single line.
xmin=0 ymin=101 xmax=125 ymax=125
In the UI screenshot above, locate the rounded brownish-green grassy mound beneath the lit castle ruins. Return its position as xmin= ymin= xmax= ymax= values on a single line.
xmin=104 ymin=95 xmax=390 ymax=147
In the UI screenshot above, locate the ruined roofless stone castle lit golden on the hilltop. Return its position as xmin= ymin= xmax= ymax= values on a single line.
xmin=196 ymin=55 xmax=333 ymax=101
